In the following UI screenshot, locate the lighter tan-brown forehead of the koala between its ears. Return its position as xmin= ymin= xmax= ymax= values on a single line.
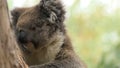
xmin=17 ymin=8 xmax=38 ymax=26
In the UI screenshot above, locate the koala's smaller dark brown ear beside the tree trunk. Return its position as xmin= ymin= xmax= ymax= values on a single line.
xmin=11 ymin=8 xmax=25 ymax=27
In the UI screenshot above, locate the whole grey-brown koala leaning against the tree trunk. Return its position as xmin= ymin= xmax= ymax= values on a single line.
xmin=11 ymin=0 xmax=86 ymax=68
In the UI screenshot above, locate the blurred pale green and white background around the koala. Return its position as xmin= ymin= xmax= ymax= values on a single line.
xmin=8 ymin=0 xmax=120 ymax=68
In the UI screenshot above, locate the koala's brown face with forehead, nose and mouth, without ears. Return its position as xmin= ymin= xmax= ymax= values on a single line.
xmin=16 ymin=9 xmax=49 ymax=48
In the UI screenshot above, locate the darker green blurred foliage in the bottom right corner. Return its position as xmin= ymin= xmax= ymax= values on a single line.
xmin=97 ymin=44 xmax=120 ymax=68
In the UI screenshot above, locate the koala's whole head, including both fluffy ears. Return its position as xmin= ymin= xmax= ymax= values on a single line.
xmin=11 ymin=0 xmax=65 ymax=52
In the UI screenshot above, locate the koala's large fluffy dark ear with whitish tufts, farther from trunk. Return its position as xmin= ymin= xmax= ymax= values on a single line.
xmin=38 ymin=0 xmax=65 ymax=23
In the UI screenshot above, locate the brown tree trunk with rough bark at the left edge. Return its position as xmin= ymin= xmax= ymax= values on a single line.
xmin=0 ymin=0 xmax=28 ymax=68
